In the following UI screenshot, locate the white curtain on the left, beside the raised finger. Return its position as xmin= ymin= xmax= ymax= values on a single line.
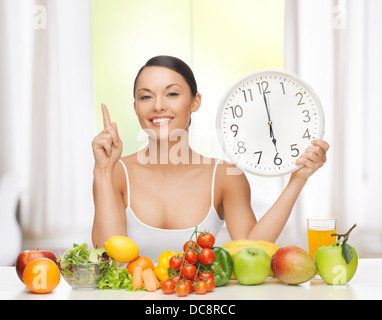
xmin=0 ymin=0 xmax=94 ymax=250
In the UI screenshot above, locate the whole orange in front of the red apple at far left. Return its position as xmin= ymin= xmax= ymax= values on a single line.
xmin=23 ymin=258 xmax=61 ymax=293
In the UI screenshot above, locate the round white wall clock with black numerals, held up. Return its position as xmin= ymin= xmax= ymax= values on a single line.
xmin=217 ymin=70 xmax=324 ymax=176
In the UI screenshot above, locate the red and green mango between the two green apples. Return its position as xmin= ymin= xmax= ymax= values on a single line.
xmin=272 ymin=245 xmax=317 ymax=284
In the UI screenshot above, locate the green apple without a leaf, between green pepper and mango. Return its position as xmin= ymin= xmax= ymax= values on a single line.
xmin=233 ymin=247 xmax=271 ymax=285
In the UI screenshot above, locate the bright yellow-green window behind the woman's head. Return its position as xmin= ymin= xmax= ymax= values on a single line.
xmin=92 ymin=0 xmax=284 ymax=156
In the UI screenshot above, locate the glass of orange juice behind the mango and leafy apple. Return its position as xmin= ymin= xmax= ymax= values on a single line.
xmin=308 ymin=217 xmax=337 ymax=261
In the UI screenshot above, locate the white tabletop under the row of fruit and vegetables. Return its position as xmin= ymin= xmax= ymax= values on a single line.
xmin=0 ymin=259 xmax=382 ymax=303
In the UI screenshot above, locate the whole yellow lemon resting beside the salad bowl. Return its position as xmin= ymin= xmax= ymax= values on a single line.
xmin=104 ymin=236 xmax=139 ymax=263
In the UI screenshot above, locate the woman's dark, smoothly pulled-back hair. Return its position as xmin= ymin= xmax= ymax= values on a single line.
xmin=133 ymin=56 xmax=198 ymax=97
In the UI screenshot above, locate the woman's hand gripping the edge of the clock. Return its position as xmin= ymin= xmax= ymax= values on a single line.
xmin=292 ymin=139 xmax=329 ymax=180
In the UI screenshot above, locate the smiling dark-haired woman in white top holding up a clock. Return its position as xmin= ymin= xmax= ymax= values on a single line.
xmin=92 ymin=56 xmax=329 ymax=259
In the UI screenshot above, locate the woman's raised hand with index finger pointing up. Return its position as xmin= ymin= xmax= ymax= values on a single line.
xmin=92 ymin=104 xmax=123 ymax=173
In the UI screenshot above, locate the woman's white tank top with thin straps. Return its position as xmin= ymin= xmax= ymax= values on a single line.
xmin=119 ymin=160 xmax=224 ymax=262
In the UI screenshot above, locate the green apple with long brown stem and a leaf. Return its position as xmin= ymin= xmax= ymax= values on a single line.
xmin=314 ymin=241 xmax=358 ymax=285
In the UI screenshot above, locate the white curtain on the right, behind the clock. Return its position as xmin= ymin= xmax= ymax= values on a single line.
xmin=285 ymin=0 xmax=382 ymax=257
